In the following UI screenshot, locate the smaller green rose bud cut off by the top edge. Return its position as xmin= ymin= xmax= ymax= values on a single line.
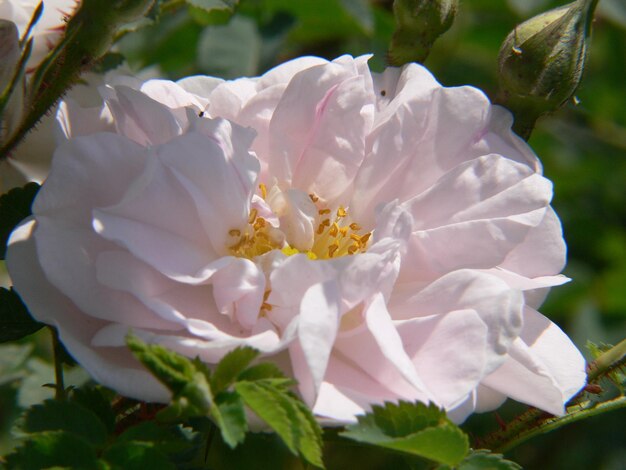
xmin=387 ymin=0 xmax=458 ymax=67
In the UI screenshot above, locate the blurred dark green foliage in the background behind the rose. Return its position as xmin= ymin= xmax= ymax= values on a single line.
xmin=0 ymin=0 xmax=626 ymax=470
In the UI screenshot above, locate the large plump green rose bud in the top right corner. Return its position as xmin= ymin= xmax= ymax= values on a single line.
xmin=498 ymin=0 xmax=597 ymax=137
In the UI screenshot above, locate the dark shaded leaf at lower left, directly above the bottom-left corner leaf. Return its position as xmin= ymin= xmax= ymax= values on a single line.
xmin=22 ymin=400 xmax=107 ymax=446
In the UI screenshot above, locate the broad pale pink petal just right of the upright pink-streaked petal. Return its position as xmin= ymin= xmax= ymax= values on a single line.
xmin=352 ymin=87 xmax=490 ymax=224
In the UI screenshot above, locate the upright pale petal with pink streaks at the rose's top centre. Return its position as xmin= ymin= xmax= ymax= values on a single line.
xmin=269 ymin=55 xmax=373 ymax=202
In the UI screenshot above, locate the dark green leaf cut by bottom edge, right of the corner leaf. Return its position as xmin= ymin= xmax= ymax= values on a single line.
xmin=102 ymin=441 xmax=176 ymax=470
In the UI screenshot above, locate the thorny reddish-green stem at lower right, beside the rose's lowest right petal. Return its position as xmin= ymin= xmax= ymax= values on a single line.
xmin=476 ymin=339 xmax=626 ymax=453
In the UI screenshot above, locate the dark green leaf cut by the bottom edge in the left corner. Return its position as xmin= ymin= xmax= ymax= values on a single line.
xmin=6 ymin=431 xmax=101 ymax=470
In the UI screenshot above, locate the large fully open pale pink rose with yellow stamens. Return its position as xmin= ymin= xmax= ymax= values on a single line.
xmin=7 ymin=56 xmax=585 ymax=423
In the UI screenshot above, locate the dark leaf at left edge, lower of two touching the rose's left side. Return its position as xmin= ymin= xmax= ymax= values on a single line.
xmin=0 ymin=287 xmax=44 ymax=343
